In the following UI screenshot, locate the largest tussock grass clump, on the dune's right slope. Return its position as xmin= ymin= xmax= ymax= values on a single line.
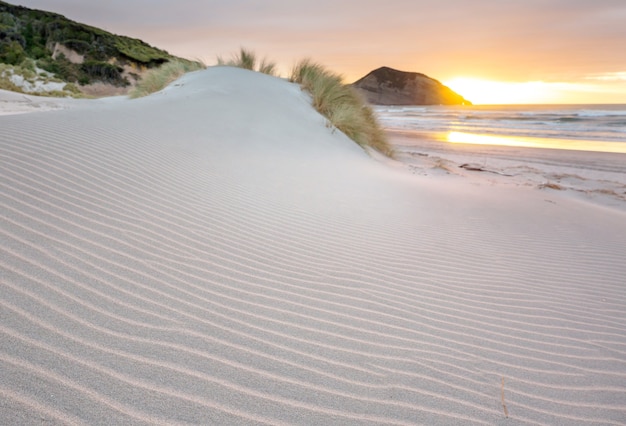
xmin=290 ymin=59 xmax=393 ymax=157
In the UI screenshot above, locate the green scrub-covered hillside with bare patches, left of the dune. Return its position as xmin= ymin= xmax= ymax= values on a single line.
xmin=0 ymin=1 xmax=188 ymax=95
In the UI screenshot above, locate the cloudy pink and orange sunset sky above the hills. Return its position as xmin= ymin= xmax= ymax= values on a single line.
xmin=9 ymin=0 xmax=626 ymax=104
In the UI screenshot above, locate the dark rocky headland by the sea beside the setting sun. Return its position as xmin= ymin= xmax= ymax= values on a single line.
xmin=352 ymin=67 xmax=472 ymax=105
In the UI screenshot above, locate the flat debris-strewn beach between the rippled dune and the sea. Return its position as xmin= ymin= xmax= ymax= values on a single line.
xmin=386 ymin=129 xmax=626 ymax=211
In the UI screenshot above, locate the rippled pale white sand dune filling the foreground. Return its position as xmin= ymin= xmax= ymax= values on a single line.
xmin=0 ymin=68 xmax=626 ymax=425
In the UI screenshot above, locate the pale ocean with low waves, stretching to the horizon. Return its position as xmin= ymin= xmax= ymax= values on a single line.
xmin=374 ymin=104 xmax=626 ymax=153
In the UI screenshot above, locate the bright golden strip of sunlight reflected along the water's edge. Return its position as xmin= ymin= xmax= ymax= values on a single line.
xmin=447 ymin=132 xmax=626 ymax=154
